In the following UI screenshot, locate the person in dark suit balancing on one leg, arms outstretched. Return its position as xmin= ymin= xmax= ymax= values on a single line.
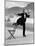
xmin=17 ymin=11 xmax=30 ymax=37
